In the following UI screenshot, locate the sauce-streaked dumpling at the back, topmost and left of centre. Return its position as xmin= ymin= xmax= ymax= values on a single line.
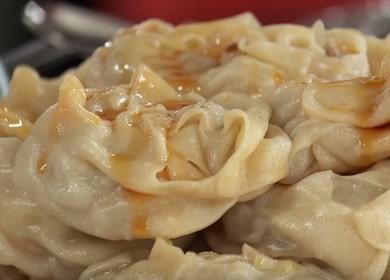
xmin=76 ymin=13 xmax=265 ymax=92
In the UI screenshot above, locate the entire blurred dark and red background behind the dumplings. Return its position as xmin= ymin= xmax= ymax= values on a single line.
xmin=0 ymin=0 xmax=390 ymax=86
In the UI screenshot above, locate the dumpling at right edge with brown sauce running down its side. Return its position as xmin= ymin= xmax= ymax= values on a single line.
xmin=278 ymin=77 xmax=390 ymax=183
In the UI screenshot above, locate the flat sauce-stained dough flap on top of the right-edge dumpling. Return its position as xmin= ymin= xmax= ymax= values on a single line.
xmin=302 ymin=77 xmax=390 ymax=128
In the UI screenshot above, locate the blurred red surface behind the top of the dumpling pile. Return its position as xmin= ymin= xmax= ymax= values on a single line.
xmin=95 ymin=0 xmax=372 ymax=24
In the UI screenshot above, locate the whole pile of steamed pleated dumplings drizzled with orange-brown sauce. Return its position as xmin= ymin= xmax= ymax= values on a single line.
xmin=0 ymin=13 xmax=390 ymax=280
